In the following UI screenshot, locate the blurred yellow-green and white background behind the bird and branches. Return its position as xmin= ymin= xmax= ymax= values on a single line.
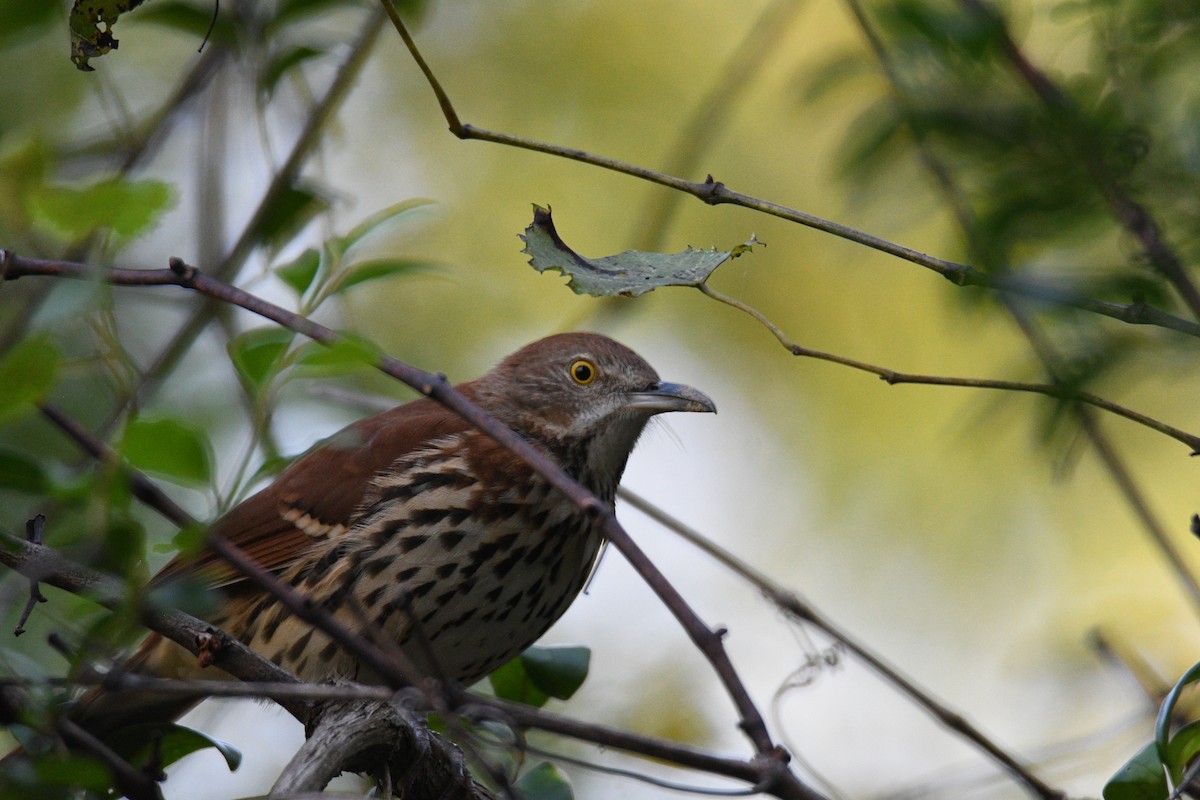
xmin=0 ymin=0 xmax=1200 ymax=799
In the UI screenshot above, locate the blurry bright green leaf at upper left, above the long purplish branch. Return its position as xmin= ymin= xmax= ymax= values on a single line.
xmin=26 ymin=178 xmax=174 ymax=239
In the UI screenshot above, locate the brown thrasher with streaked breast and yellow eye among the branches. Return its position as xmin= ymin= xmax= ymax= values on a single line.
xmin=73 ymin=333 xmax=716 ymax=733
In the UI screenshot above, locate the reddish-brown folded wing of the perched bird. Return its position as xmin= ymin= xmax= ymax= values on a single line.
xmin=151 ymin=398 xmax=469 ymax=588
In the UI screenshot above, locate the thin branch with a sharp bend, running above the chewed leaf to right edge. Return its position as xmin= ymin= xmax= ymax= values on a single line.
xmin=380 ymin=0 xmax=1200 ymax=338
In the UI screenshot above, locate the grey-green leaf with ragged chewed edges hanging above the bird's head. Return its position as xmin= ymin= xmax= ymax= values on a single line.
xmin=521 ymin=205 xmax=762 ymax=297
